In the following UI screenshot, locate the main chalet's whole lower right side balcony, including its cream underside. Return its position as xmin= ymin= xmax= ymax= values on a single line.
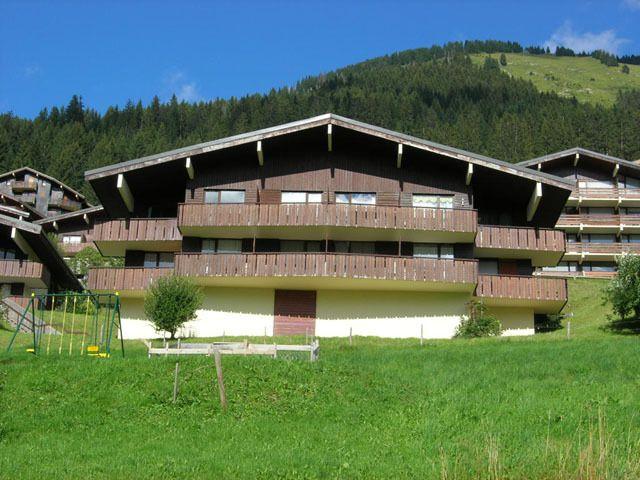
xmin=476 ymin=275 xmax=567 ymax=313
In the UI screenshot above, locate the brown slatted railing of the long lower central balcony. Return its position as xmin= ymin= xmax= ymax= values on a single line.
xmin=175 ymin=253 xmax=478 ymax=284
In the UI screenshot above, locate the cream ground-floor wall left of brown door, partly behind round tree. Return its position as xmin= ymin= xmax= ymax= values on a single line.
xmin=121 ymin=287 xmax=274 ymax=339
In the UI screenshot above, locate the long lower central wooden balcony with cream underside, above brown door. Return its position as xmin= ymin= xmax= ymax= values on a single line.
xmin=176 ymin=253 xmax=478 ymax=292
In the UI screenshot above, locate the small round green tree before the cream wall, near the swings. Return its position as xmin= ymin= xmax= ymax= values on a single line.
xmin=144 ymin=275 xmax=202 ymax=339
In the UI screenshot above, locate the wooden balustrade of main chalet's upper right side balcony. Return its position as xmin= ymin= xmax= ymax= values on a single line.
xmin=475 ymin=225 xmax=565 ymax=252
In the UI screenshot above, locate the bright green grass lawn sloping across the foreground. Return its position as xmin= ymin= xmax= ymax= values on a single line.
xmin=0 ymin=280 xmax=640 ymax=479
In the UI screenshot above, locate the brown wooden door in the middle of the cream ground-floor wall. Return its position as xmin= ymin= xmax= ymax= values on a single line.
xmin=273 ymin=290 xmax=316 ymax=335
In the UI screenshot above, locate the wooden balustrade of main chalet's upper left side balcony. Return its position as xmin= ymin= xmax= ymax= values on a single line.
xmin=92 ymin=218 xmax=182 ymax=242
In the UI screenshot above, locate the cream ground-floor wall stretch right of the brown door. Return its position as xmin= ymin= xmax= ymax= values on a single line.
xmin=316 ymin=290 xmax=469 ymax=338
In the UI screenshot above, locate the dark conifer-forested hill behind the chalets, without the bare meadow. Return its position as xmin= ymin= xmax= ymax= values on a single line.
xmin=0 ymin=42 xmax=640 ymax=198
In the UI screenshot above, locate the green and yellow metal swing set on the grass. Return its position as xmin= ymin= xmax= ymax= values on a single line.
xmin=7 ymin=292 xmax=124 ymax=358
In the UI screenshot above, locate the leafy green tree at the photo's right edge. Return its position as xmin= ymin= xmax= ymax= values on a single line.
xmin=603 ymin=255 xmax=640 ymax=319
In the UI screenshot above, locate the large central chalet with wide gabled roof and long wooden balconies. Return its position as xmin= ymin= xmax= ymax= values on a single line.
xmin=85 ymin=114 xmax=574 ymax=338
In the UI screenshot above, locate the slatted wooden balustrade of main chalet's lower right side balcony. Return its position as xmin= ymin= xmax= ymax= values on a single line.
xmin=476 ymin=275 xmax=567 ymax=301
